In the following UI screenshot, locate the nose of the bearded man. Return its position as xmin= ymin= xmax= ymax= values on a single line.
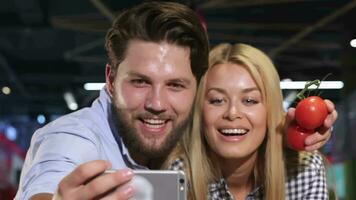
xmin=145 ymin=87 xmax=167 ymax=114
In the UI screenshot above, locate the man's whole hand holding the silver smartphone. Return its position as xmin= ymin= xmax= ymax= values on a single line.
xmin=53 ymin=160 xmax=135 ymax=200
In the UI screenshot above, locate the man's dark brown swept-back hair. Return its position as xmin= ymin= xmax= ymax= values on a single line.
xmin=105 ymin=2 xmax=209 ymax=80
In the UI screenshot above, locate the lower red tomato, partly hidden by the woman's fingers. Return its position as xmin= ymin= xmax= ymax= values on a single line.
xmin=287 ymin=123 xmax=314 ymax=151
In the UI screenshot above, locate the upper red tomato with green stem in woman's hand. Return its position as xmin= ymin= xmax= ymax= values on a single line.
xmin=295 ymin=96 xmax=328 ymax=130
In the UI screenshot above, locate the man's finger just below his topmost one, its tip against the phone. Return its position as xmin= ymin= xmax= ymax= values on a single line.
xmin=82 ymin=169 xmax=134 ymax=199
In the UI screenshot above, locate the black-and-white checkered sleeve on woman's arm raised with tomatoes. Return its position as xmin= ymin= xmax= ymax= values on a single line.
xmin=286 ymin=152 xmax=329 ymax=200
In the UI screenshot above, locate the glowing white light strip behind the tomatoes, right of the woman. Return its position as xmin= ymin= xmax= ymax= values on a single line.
xmin=281 ymin=81 xmax=344 ymax=90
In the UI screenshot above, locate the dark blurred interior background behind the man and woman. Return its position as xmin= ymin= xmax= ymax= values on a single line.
xmin=0 ymin=0 xmax=356 ymax=200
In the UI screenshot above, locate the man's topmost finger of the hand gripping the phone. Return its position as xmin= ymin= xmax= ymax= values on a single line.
xmin=60 ymin=160 xmax=111 ymax=189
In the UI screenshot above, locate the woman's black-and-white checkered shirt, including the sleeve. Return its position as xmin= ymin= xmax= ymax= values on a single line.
xmin=170 ymin=152 xmax=329 ymax=200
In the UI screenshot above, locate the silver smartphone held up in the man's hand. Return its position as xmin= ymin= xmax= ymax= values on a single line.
xmin=106 ymin=170 xmax=187 ymax=200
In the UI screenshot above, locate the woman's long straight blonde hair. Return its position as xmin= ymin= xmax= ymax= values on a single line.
xmin=167 ymin=43 xmax=286 ymax=200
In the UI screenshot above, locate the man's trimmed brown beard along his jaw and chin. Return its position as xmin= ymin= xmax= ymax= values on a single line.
xmin=112 ymin=104 xmax=192 ymax=159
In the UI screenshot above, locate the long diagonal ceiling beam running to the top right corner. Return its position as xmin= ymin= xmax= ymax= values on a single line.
xmin=268 ymin=0 xmax=356 ymax=57
